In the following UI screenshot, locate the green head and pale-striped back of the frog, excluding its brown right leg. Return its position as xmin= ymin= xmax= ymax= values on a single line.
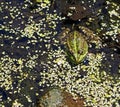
xmin=59 ymin=30 xmax=88 ymax=64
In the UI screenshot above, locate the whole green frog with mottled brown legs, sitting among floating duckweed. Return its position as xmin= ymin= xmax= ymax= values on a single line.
xmin=59 ymin=26 xmax=99 ymax=64
